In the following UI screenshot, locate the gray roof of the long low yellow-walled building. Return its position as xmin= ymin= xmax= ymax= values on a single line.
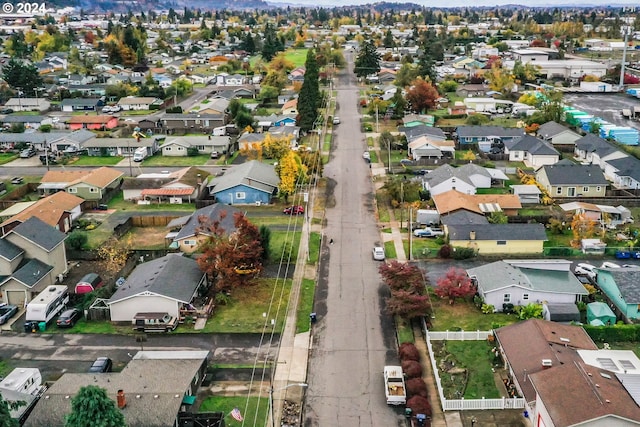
xmin=448 ymin=224 xmax=547 ymax=241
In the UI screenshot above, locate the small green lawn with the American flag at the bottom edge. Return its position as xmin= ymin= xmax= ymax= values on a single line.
xmin=200 ymin=395 xmax=269 ymax=427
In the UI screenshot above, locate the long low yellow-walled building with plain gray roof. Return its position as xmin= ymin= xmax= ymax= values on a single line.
xmin=446 ymin=224 xmax=547 ymax=255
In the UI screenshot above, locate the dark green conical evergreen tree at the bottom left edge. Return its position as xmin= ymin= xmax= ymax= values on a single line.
xmin=65 ymin=385 xmax=126 ymax=427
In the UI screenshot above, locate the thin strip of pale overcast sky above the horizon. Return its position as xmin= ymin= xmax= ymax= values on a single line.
xmin=266 ymin=0 xmax=631 ymax=7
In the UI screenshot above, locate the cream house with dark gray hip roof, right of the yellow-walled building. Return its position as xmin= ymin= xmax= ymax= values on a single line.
xmin=536 ymin=160 xmax=609 ymax=198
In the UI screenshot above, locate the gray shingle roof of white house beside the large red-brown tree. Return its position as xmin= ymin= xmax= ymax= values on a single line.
xmin=108 ymin=254 xmax=204 ymax=303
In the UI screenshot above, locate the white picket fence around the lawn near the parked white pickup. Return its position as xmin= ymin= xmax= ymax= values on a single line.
xmin=423 ymin=322 xmax=525 ymax=411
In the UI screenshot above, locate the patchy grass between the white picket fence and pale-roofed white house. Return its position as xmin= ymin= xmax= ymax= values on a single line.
xmin=430 ymin=296 xmax=518 ymax=331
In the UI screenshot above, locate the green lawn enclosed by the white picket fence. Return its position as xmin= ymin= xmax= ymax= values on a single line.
xmin=432 ymin=340 xmax=500 ymax=399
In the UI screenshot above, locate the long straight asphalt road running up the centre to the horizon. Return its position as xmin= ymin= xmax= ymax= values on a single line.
xmin=304 ymin=51 xmax=405 ymax=427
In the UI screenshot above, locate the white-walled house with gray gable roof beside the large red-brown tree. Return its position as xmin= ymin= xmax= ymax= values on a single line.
xmin=107 ymin=254 xmax=207 ymax=323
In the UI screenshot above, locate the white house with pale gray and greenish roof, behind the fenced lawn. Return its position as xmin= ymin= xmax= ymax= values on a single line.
xmin=467 ymin=260 xmax=588 ymax=320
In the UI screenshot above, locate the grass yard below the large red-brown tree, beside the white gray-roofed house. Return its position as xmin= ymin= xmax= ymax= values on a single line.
xmin=202 ymin=279 xmax=291 ymax=333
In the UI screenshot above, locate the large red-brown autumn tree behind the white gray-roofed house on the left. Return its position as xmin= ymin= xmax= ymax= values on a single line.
xmin=198 ymin=212 xmax=263 ymax=291
